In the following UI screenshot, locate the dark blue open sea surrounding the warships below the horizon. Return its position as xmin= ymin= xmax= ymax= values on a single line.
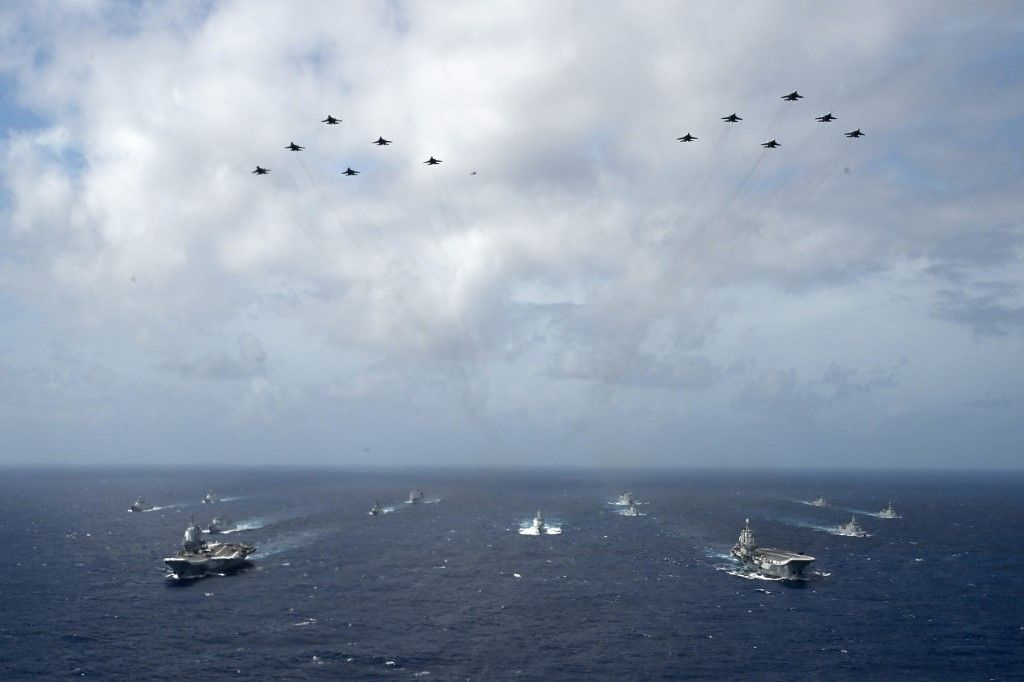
xmin=0 ymin=468 xmax=1024 ymax=680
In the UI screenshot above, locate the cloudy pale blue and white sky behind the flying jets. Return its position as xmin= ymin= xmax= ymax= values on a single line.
xmin=0 ymin=0 xmax=1024 ymax=470
